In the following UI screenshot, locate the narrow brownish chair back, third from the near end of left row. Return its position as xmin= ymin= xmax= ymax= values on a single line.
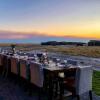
xmin=11 ymin=58 xmax=18 ymax=74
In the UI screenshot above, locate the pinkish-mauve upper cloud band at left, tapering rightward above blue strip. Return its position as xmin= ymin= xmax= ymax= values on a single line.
xmin=0 ymin=30 xmax=65 ymax=39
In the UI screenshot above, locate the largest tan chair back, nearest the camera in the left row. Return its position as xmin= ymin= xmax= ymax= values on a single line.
xmin=30 ymin=63 xmax=44 ymax=87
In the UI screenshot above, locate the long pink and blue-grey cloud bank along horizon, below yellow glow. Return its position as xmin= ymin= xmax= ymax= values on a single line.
xmin=0 ymin=30 xmax=92 ymax=43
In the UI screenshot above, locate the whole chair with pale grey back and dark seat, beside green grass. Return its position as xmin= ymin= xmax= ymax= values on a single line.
xmin=63 ymin=66 xmax=93 ymax=100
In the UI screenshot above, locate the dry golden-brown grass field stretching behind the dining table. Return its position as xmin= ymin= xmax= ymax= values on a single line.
xmin=0 ymin=44 xmax=100 ymax=58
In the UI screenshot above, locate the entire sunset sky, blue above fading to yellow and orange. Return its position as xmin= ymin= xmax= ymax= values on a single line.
xmin=0 ymin=0 xmax=100 ymax=43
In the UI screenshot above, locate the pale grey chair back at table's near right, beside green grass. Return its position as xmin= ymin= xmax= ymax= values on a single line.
xmin=75 ymin=66 xmax=93 ymax=95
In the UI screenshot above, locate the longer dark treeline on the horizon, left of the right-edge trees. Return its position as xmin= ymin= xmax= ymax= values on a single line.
xmin=41 ymin=41 xmax=86 ymax=46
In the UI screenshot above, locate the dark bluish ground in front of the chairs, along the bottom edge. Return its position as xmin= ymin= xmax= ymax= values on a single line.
xmin=0 ymin=77 xmax=100 ymax=100
